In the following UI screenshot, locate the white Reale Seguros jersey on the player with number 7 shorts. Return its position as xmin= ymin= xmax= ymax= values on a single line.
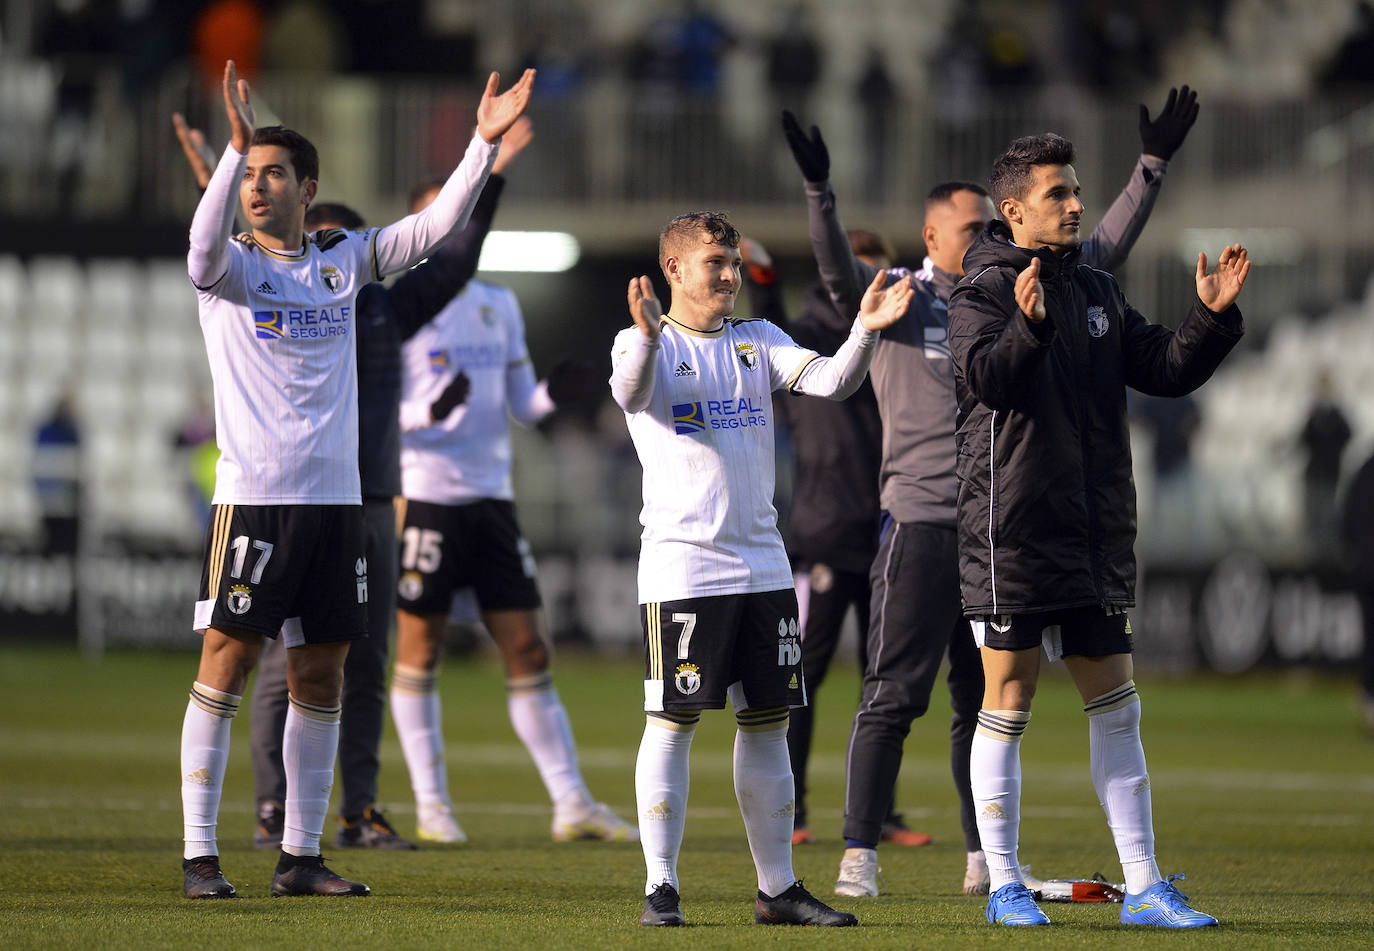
xmin=611 ymin=319 xmax=818 ymax=603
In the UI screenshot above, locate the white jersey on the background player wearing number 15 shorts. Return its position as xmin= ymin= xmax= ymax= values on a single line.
xmin=401 ymin=280 xmax=534 ymax=506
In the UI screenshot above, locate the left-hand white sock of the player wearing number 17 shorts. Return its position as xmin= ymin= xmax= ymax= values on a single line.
xmin=181 ymin=682 xmax=243 ymax=859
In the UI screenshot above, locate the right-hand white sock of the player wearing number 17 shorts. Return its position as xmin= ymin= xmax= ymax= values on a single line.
xmin=282 ymin=697 xmax=344 ymax=855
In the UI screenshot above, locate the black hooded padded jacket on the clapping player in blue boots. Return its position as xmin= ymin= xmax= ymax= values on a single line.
xmin=949 ymin=221 xmax=1243 ymax=616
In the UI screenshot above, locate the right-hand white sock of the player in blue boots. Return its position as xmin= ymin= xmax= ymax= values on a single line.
xmin=1083 ymin=680 xmax=1161 ymax=895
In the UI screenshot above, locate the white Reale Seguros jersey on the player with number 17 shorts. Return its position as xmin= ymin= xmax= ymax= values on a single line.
xmin=196 ymin=230 xmax=376 ymax=506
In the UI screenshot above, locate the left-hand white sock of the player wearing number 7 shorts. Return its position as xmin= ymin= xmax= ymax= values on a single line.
xmin=635 ymin=716 xmax=697 ymax=895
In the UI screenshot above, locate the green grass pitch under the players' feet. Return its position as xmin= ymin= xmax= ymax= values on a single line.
xmin=0 ymin=643 xmax=1374 ymax=951
